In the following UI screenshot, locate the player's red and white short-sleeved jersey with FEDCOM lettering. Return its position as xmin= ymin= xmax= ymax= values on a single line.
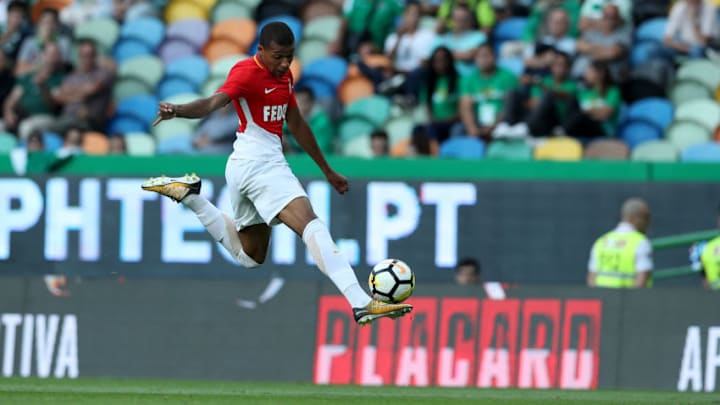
xmin=218 ymin=56 xmax=297 ymax=161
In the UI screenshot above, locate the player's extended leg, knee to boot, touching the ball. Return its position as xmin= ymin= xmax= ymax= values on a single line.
xmin=278 ymin=197 xmax=412 ymax=324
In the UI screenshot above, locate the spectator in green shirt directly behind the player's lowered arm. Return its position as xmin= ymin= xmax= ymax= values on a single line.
xmin=284 ymin=87 xmax=335 ymax=154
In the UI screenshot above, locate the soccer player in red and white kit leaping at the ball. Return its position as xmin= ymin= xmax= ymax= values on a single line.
xmin=142 ymin=22 xmax=412 ymax=324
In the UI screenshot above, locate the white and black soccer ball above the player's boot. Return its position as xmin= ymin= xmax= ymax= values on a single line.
xmin=368 ymin=259 xmax=415 ymax=304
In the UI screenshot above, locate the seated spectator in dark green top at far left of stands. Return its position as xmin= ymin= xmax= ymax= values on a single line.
xmin=3 ymin=42 xmax=65 ymax=139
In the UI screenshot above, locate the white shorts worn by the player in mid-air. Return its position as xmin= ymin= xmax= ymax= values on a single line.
xmin=225 ymin=158 xmax=307 ymax=231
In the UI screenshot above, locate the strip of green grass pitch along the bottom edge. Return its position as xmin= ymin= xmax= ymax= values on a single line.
xmin=0 ymin=378 xmax=720 ymax=405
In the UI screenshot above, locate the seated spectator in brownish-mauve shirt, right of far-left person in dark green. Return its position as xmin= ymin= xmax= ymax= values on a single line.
xmin=52 ymin=39 xmax=114 ymax=133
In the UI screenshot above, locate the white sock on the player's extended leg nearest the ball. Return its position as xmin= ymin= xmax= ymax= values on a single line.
xmin=303 ymin=218 xmax=371 ymax=308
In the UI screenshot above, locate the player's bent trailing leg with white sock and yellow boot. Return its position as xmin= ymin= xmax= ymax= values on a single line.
xmin=142 ymin=174 xmax=270 ymax=268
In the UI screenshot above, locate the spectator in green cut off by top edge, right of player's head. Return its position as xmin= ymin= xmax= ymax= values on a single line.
xmin=330 ymin=0 xmax=403 ymax=57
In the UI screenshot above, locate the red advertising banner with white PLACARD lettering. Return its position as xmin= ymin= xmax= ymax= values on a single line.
xmin=314 ymin=295 xmax=602 ymax=389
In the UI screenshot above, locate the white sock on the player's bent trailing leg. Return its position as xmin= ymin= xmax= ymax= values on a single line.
xmin=182 ymin=194 xmax=260 ymax=268
